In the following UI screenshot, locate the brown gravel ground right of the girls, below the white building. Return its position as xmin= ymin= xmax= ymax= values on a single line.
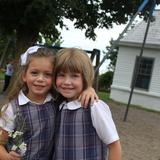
xmin=108 ymin=101 xmax=160 ymax=160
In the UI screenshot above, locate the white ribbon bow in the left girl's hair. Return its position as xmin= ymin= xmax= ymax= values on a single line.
xmin=21 ymin=46 xmax=42 ymax=66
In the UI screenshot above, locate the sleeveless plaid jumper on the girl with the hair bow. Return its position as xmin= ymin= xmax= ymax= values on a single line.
xmin=12 ymin=100 xmax=56 ymax=160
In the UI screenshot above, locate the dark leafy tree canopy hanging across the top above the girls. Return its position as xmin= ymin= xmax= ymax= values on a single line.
xmin=0 ymin=0 xmax=159 ymax=56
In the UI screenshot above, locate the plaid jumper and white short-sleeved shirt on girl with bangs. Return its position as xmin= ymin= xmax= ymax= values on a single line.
xmin=53 ymin=100 xmax=119 ymax=160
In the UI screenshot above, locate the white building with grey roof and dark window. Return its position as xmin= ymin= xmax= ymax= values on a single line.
xmin=110 ymin=10 xmax=160 ymax=111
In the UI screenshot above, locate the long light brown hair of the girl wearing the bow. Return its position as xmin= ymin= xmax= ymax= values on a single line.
xmin=0 ymin=48 xmax=57 ymax=118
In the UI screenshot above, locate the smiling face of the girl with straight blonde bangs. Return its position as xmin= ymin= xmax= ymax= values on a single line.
xmin=56 ymin=72 xmax=83 ymax=101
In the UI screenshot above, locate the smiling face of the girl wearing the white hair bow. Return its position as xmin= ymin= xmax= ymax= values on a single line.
xmin=22 ymin=57 xmax=53 ymax=103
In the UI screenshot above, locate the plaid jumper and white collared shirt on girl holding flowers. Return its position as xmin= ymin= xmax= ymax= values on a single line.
xmin=0 ymin=91 xmax=56 ymax=160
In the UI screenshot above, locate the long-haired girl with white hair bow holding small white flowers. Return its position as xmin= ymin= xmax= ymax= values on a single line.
xmin=0 ymin=46 xmax=97 ymax=160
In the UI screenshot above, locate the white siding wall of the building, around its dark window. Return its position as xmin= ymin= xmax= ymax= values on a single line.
xmin=110 ymin=46 xmax=160 ymax=111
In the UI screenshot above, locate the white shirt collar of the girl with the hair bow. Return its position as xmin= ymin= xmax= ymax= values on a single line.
xmin=18 ymin=90 xmax=53 ymax=105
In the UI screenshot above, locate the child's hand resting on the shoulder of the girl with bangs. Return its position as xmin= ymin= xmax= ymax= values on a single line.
xmin=78 ymin=87 xmax=99 ymax=108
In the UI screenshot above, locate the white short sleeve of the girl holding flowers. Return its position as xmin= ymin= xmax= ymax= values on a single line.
xmin=0 ymin=103 xmax=15 ymax=132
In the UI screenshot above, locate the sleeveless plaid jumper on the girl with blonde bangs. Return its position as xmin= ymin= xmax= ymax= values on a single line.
xmin=53 ymin=107 xmax=107 ymax=160
